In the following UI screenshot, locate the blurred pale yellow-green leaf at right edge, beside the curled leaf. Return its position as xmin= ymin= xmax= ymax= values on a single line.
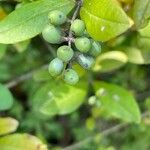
xmin=124 ymin=47 xmax=150 ymax=65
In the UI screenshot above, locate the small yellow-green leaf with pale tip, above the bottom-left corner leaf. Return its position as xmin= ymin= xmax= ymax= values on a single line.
xmin=0 ymin=117 xmax=19 ymax=135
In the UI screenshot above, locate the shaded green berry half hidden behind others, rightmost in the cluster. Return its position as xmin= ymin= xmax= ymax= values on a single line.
xmin=89 ymin=40 xmax=101 ymax=57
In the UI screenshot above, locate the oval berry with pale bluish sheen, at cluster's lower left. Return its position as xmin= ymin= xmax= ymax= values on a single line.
xmin=48 ymin=58 xmax=64 ymax=77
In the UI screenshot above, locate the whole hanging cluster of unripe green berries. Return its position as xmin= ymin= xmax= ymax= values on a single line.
xmin=42 ymin=10 xmax=101 ymax=85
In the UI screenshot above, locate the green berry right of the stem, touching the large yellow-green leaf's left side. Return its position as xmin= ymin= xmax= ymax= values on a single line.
xmin=71 ymin=19 xmax=85 ymax=36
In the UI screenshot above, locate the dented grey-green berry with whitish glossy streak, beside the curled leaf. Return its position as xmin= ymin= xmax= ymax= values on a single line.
xmin=77 ymin=54 xmax=95 ymax=70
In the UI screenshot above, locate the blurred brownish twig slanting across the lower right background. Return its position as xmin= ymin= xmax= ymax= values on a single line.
xmin=62 ymin=111 xmax=150 ymax=150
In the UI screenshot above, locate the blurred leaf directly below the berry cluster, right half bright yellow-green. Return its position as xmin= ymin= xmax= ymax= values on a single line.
xmin=33 ymin=81 xmax=86 ymax=116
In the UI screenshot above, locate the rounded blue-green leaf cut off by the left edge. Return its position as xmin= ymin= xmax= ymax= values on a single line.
xmin=0 ymin=84 xmax=13 ymax=111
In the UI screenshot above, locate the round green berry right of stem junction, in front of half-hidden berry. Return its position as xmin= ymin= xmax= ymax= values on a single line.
xmin=75 ymin=37 xmax=91 ymax=53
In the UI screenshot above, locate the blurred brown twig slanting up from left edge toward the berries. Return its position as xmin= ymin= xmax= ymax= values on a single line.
xmin=5 ymin=64 xmax=48 ymax=88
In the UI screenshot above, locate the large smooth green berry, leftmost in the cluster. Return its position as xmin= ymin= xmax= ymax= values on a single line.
xmin=42 ymin=25 xmax=62 ymax=44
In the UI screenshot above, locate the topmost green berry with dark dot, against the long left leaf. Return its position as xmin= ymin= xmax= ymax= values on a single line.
xmin=48 ymin=10 xmax=67 ymax=26
